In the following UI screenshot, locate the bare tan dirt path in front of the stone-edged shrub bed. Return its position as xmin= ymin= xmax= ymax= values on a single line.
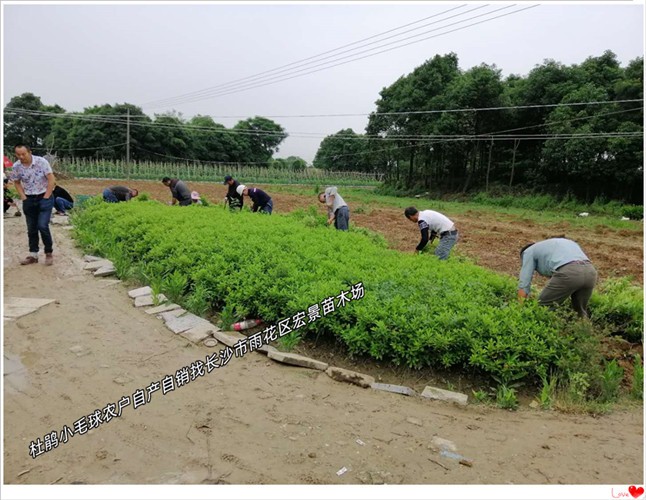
xmin=3 ymin=214 xmax=643 ymax=484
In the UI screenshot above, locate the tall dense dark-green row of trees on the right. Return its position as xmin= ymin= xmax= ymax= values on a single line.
xmin=314 ymin=51 xmax=644 ymax=204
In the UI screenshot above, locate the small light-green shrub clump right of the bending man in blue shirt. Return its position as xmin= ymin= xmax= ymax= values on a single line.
xmin=590 ymin=278 xmax=644 ymax=342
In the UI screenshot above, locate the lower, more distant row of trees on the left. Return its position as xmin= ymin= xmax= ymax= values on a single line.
xmin=4 ymin=93 xmax=307 ymax=170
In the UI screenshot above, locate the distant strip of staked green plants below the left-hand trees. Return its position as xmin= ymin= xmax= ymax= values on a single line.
xmin=59 ymin=158 xmax=379 ymax=186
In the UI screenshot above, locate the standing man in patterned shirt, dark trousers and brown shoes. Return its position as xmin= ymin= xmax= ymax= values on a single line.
xmin=11 ymin=144 xmax=56 ymax=266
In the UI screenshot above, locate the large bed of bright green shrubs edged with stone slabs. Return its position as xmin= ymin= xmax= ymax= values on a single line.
xmin=74 ymin=199 xmax=643 ymax=410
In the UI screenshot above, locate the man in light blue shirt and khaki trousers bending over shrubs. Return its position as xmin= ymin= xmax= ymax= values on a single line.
xmin=518 ymin=238 xmax=597 ymax=318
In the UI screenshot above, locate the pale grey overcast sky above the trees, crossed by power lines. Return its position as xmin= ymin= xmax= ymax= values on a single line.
xmin=2 ymin=2 xmax=644 ymax=162
